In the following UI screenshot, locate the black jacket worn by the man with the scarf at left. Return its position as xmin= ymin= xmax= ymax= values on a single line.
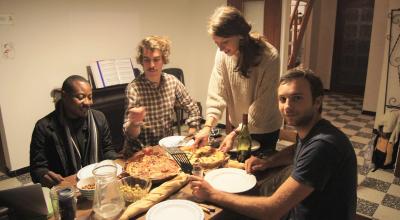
xmin=30 ymin=105 xmax=117 ymax=183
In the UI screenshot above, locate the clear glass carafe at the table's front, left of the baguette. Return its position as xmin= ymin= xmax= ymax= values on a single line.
xmin=93 ymin=160 xmax=125 ymax=219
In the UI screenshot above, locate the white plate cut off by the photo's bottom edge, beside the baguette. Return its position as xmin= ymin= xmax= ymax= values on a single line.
xmin=146 ymin=199 xmax=204 ymax=220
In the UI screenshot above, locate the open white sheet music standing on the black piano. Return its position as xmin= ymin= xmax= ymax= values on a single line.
xmin=90 ymin=58 xmax=135 ymax=88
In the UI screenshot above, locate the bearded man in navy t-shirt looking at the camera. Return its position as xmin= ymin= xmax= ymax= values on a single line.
xmin=191 ymin=69 xmax=357 ymax=220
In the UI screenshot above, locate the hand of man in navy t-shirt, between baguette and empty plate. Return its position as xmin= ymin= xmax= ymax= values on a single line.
xmin=189 ymin=176 xmax=217 ymax=201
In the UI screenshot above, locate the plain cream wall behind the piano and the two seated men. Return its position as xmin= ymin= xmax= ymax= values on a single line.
xmin=0 ymin=0 xmax=226 ymax=171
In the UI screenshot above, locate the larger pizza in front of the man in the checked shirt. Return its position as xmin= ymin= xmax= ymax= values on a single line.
xmin=125 ymin=146 xmax=180 ymax=181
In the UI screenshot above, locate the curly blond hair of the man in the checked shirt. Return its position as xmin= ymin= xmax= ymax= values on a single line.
xmin=136 ymin=35 xmax=171 ymax=64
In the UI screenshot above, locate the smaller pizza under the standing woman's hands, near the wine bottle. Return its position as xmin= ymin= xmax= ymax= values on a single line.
xmin=180 ymin=146 xmax=229 ymax=169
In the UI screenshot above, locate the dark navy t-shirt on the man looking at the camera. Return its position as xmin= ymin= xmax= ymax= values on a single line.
xmin=289 ymin=119 xmax=357 ymax=220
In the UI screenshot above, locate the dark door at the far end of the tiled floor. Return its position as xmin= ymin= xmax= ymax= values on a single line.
xmin=331 ymin=0 xmax=374 ymax=95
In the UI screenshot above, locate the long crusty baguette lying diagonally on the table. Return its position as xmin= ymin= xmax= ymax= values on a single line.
xmin=120 ymin=173 xmax=188 ymax=220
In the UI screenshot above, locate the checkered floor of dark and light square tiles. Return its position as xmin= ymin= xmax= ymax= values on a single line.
xmin=0 ymin=94 xmax=400 ymax=220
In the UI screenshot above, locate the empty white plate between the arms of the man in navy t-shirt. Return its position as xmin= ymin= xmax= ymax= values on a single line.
xmin=204 ymin=168 xmax=257 ymax=193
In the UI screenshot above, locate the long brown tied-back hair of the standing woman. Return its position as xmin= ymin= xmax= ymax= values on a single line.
xmin=208 ymin=6 xmax=266 ymax=78
